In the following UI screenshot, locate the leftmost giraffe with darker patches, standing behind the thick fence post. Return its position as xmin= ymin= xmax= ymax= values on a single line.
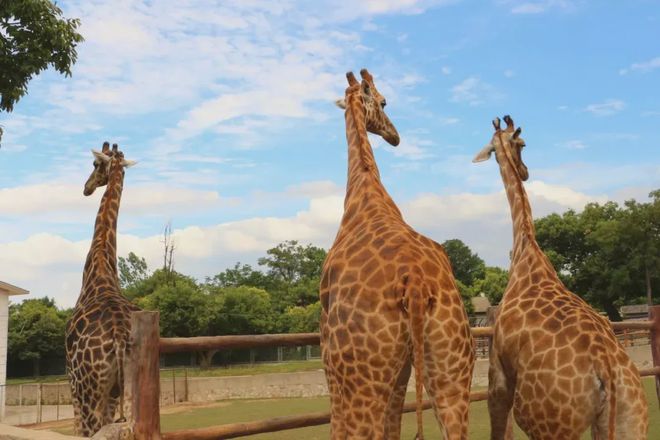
xmin=66 ymin=142 xmax=138 ymax=436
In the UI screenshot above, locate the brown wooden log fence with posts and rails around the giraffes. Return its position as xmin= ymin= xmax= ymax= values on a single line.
xmin=124 ymin=306 xmax=660 ymax=440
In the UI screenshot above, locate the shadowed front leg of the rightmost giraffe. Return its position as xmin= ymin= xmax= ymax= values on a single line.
xmin=488 ymin=349 xmax=515 ymax=440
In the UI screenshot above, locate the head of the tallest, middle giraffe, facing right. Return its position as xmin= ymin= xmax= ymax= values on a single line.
xmin=336 ymin=69 xmax=399 ymax=147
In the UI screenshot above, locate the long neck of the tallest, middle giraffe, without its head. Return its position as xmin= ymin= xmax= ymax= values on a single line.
xmin=342 ymin=93 xmax=401 ymax=224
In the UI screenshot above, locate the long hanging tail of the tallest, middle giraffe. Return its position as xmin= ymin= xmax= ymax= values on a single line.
xmin=405 ymin=276 xmax=425 ymax=440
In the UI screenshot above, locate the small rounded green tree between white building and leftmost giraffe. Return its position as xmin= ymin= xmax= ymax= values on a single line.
xmin=7 ymin=297 xmax=67 ymax=376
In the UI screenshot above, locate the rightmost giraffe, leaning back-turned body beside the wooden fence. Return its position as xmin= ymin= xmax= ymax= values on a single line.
xmin=474 ymin=116 xmax=648 ymax=440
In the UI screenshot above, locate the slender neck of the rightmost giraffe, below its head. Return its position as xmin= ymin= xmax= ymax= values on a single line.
xmin=495 ymin=135 xmax=538 ymax=266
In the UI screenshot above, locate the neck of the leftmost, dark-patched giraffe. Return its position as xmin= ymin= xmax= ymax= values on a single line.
xmin=78 ymin=159 xmax=124 ymax=302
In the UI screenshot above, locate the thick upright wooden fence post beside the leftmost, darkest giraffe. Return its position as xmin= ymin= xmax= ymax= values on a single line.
xmin=125 ymin=312 xmax=161 ymax=440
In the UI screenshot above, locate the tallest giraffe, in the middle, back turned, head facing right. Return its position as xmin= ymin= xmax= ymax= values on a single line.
xmin=320 ymin=69 xmax=474 ymax=440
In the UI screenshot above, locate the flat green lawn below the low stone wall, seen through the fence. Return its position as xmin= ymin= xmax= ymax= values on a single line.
xmin=51 ymin=378 xmax=660 ymax=440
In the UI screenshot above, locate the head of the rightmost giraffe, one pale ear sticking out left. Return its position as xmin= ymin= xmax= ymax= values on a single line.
xmin=472 ymin=115 xmax=529 ymax=181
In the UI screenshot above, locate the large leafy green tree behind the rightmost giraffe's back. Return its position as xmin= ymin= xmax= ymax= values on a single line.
xmin=535 ymin=196 xmax=660 ymax=321
